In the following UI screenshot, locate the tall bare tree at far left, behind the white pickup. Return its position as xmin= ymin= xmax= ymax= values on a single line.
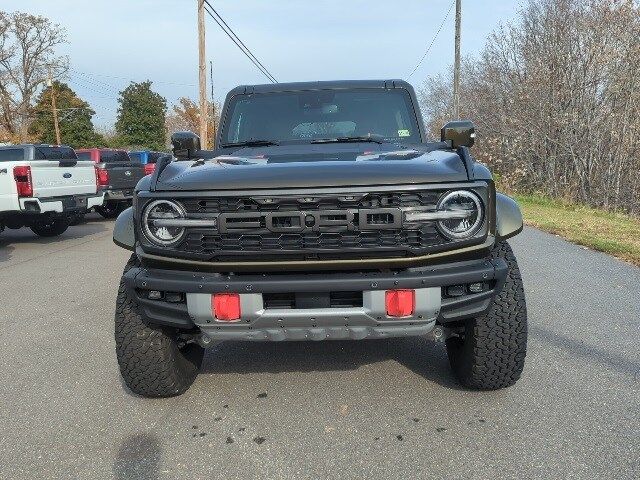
xmin=0 ymin=11 xmax=68 ymax=141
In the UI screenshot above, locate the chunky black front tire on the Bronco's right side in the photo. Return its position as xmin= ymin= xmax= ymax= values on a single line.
xmin=447 ymin=242 xmax=527 ymax=390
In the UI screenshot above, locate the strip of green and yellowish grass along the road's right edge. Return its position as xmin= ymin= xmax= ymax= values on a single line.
xmin=515 ymin=195 xmax=640 ymax=266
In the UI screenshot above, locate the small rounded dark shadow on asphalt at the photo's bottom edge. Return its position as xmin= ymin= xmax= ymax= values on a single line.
xmin=113 ymin=433 xmax=162 ymax=480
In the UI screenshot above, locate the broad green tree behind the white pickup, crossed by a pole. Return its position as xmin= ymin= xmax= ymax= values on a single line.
xmin=29 ymin=81 xmax=102 ymax=148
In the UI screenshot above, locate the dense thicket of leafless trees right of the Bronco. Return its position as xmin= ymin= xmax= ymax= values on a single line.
xmin=421 ymin=0 xmax=640 ymax=214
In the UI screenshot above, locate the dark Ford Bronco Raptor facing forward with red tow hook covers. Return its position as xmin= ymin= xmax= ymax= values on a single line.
xmin=114 ymin=80 xmax=527 ymax=397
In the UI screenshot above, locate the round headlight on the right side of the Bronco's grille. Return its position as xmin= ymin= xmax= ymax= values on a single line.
xmin=438 ymin=190 xmax=484 ymax=240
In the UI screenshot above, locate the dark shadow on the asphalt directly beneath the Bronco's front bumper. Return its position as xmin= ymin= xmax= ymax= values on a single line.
xmin=201 ymin=337 xmax=465 ymax=390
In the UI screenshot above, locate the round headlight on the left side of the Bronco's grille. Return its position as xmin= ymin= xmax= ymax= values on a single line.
xmin=142 ymin=200 xmax=186 ymax=247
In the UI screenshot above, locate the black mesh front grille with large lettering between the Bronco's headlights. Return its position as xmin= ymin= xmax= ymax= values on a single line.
xmin=142 ymin=189 xmax=482 ymax=262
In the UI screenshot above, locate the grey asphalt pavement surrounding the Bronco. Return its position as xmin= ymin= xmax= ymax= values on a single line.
xmin=0 ymin=219 xmax=640 ymax=479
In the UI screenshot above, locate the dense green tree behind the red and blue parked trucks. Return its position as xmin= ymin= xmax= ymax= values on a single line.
xmin=114 ymin=80 xmax=167 ymax=150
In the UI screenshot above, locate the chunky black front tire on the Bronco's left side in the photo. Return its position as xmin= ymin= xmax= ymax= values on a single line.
xmin=115 ymin=254 xmax=204 ymax=397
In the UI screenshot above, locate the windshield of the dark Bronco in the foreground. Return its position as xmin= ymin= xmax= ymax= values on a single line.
xmin=221 ymin=88 xmax=421 ymax=145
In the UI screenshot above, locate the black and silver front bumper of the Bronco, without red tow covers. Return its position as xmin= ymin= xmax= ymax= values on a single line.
xmin=123 ymin=259 xmax=507 ymax=341
